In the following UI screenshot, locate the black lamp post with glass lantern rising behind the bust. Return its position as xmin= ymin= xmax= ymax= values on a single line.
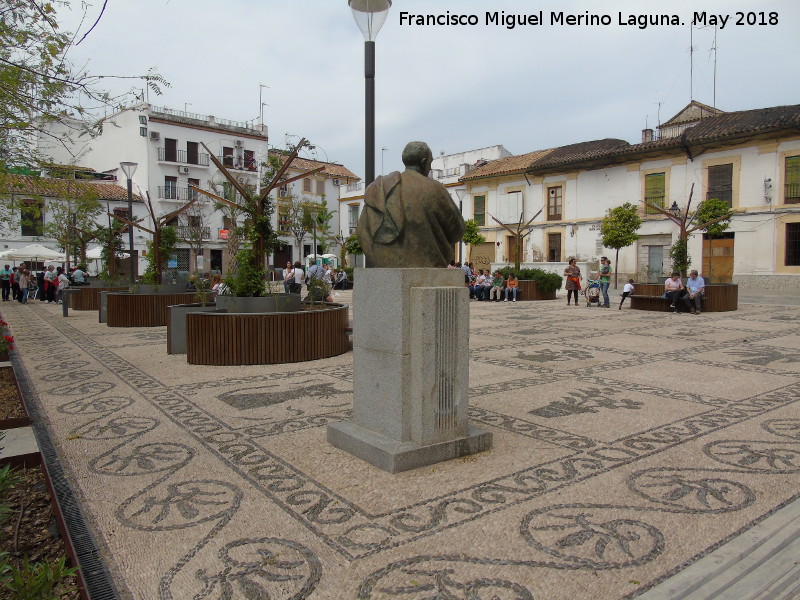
xmin=347 ymin=0 xmax=392 ymax=186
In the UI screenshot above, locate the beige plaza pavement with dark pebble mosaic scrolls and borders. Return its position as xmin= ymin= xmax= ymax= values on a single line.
xmin=2 ymin=295 xmax=800 ymax=600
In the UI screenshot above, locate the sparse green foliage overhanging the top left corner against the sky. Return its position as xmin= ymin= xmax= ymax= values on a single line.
xmin=0 ymin=0 xmax=169 ymax=168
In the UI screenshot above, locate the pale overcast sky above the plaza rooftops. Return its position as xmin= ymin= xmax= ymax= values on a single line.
xmin=62 ymin=0 xmax=800 ymax=177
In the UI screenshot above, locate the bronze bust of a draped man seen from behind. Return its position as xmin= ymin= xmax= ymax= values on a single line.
xmin=356 ymin=142 xmax=464 ymax=268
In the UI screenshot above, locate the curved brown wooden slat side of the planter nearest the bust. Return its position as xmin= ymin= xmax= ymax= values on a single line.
xmin=186 ymin=304 xmax=350 ymax=365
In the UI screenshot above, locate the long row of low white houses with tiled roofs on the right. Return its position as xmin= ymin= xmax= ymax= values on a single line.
xmin=461 ymin=103 xmax=800 ymax=288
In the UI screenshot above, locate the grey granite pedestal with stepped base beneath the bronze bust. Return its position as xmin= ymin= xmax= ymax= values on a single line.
xmin=328 ymin=269 xmax=492 ymax=473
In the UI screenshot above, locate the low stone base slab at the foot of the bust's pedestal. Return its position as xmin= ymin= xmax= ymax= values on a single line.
xmin=328 ymin=421 xmax=492 ymax=473
